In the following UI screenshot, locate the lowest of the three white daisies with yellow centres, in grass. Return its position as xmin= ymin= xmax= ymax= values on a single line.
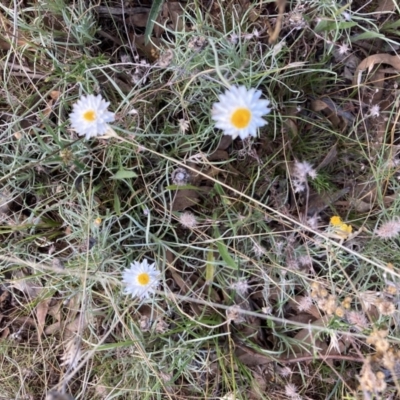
xmin=122 ymin=259 xmax=160 ymax=298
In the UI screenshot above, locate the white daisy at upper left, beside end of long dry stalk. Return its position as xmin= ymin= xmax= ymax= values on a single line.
xmin=69 ymin=94 xmax=115 ymax=140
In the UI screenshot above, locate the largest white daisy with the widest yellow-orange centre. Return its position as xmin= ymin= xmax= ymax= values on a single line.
xmin=212 ymin=86 xmax=271 ymax=139
